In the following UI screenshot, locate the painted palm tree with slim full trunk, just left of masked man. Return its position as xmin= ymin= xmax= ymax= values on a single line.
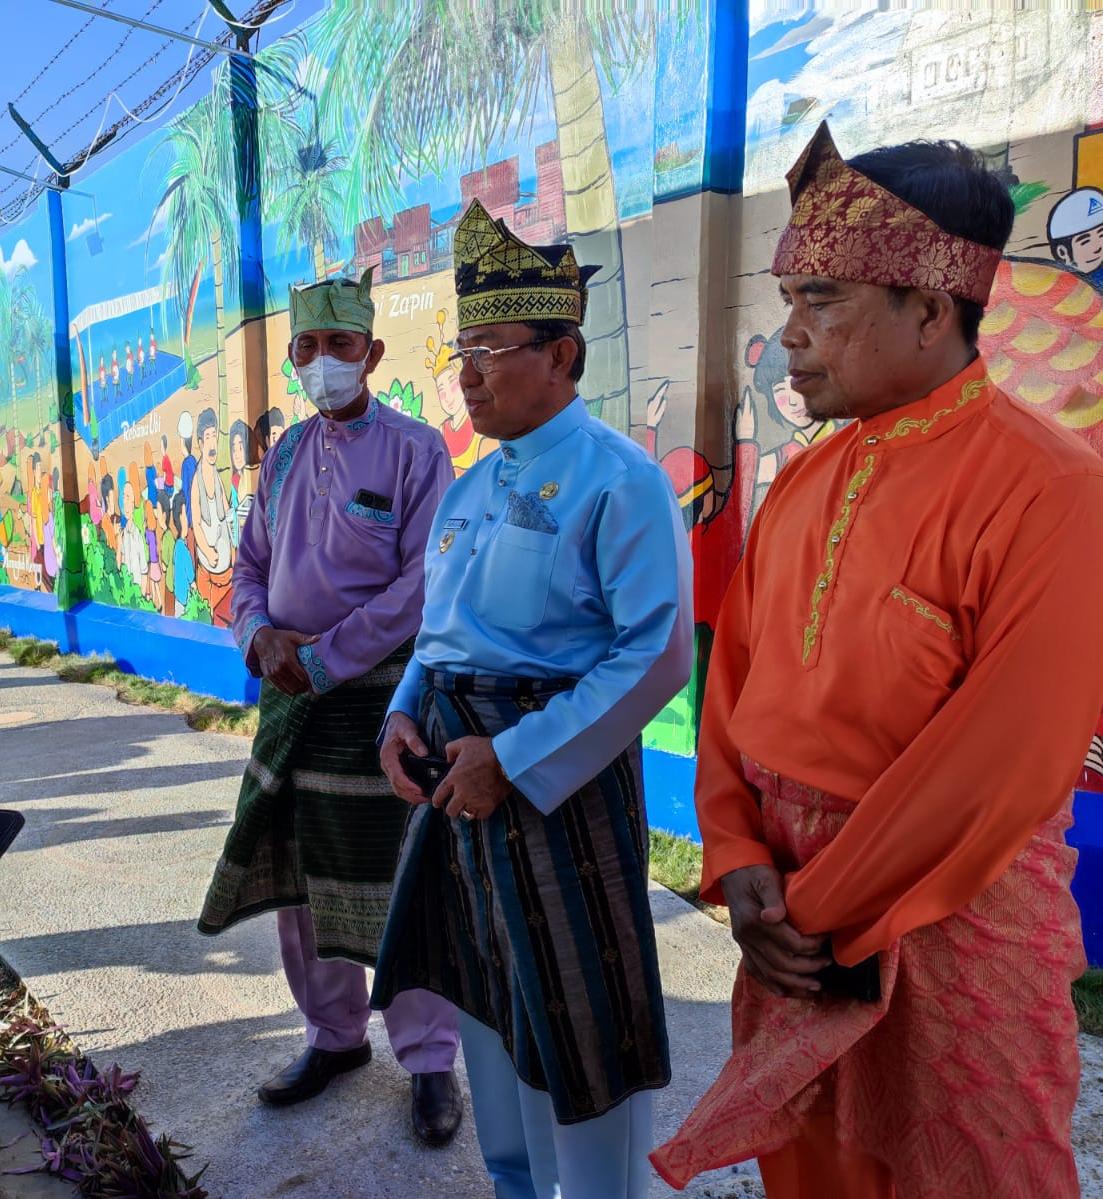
xmin=153 ymin=89 xmax=237 ymax=468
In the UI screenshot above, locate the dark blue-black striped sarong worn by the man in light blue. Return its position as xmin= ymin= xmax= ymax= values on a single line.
xmin=372 ymin=670 xmax=670 ymax=1123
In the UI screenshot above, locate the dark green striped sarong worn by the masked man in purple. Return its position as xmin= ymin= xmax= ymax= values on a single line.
xmin=199 ymin=641 xmax=412 ymax=965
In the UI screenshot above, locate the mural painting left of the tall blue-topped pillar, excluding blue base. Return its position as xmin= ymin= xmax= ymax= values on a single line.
xmin=0 ymin=0 xmax=709 ymax=753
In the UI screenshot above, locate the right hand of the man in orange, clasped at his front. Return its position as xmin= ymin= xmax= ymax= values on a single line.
xmin=721 ymin=866 xmax=831 ymax=999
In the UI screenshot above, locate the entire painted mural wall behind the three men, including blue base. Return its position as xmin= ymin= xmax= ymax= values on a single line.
xmin=0 ymin=0 xmax=1103 ymax=901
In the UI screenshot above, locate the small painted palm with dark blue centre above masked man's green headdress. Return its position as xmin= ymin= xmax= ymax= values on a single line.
xmin=265 ymin=121 xmax=348 ymax=283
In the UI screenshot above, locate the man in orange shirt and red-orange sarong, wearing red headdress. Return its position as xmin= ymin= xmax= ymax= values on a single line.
xmin=652 ymin=126 xmax=1103 ymax=1199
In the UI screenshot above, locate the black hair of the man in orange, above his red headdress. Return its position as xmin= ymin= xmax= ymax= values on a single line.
xmin=849 ymin=141 xmax=1015 ymax=347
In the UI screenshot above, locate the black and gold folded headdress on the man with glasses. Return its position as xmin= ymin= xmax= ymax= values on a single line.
xmin=453 ymin=200 xmax=601 ymax=330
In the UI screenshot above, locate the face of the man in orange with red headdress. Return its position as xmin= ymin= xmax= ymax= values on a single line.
xmin=780 ymin=275 xmax=921 ymax=421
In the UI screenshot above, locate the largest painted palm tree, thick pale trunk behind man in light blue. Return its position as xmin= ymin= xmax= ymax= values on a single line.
xmin=280 ymin=0 xmax=686 ymax=430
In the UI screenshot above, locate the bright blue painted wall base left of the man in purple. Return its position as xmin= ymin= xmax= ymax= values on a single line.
xmin=0 ymin=586 xmax=260 ymax=704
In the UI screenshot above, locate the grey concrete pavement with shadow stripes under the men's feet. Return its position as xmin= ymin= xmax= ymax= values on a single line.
xmin=0 ymin=655 xmax=761 ymax=1199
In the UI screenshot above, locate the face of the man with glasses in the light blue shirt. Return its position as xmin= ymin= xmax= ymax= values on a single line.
xmin=456 ymin=325 xmax=556 ymax=441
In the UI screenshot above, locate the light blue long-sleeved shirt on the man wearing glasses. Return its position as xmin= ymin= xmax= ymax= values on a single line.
xmin=388 ymin=398 xmax=693 ymax=813
